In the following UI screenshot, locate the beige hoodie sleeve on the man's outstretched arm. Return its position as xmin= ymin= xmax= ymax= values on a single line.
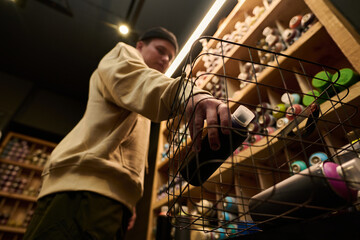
xmin=97 ymin=43 xmax=210 ymax=122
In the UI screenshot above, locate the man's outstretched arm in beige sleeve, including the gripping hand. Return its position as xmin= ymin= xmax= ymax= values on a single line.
xmin=98 ymin=42 xmax=230 ymax=150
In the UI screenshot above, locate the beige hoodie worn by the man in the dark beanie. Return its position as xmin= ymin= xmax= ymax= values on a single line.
xmin=39 ymin=43 xmax=207 ymax=209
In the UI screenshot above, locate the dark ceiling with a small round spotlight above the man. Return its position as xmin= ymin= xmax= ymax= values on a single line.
xmin=0 ymin=0 xmax=237 ymax=101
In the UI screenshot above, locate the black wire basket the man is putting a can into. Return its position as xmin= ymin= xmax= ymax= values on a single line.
xmin=167 ymin=37 xmax=360 ymax=239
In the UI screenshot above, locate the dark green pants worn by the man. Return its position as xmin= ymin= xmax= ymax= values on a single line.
xmin=24 ymin=191 xmax=132 ymax=240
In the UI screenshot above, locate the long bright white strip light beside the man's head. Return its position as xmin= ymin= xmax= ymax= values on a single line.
xmin=165 ymin=0 xmax=226 ymax=77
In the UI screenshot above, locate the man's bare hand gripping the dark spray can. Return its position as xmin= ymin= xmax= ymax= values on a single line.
xmin=185 ymin=94 xmax=231 ymax=152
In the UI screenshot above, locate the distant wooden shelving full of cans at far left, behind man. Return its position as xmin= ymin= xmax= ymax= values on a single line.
xmin=0 ymin=132 xmax=56 ymax=239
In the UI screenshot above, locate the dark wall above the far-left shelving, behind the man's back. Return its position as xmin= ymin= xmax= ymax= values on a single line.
xmin=0 ymin=72 xmax=85 ymax=142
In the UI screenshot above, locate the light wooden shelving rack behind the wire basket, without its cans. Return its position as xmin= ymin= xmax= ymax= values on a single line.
xmin=148 ymin=0 xmax=360 ymax=239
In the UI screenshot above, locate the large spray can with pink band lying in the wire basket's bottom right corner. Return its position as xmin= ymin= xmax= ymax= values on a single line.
xmin=249 ymin=161 xmax=357 ymax=228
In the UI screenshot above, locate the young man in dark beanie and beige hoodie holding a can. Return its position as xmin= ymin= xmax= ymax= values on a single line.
xmin=24 ymin=28 xmax=229 ymax=240
